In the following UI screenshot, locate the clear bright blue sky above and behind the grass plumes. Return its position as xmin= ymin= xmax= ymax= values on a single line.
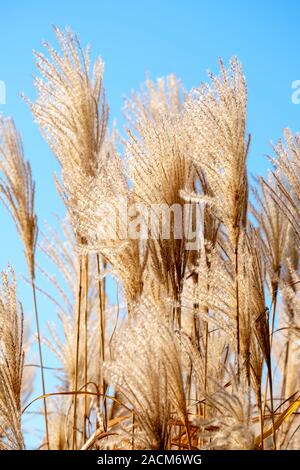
xmin=0 ymin=0 xmax=300 ymax=445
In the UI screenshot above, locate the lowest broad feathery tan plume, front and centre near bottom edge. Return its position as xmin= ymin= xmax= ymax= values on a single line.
xmin=106 ymin=299 xmax=188 ymax=450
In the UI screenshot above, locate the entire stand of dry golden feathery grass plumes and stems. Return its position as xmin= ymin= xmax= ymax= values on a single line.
xmin=0 ymin=28 xmax=300 ymax=451
